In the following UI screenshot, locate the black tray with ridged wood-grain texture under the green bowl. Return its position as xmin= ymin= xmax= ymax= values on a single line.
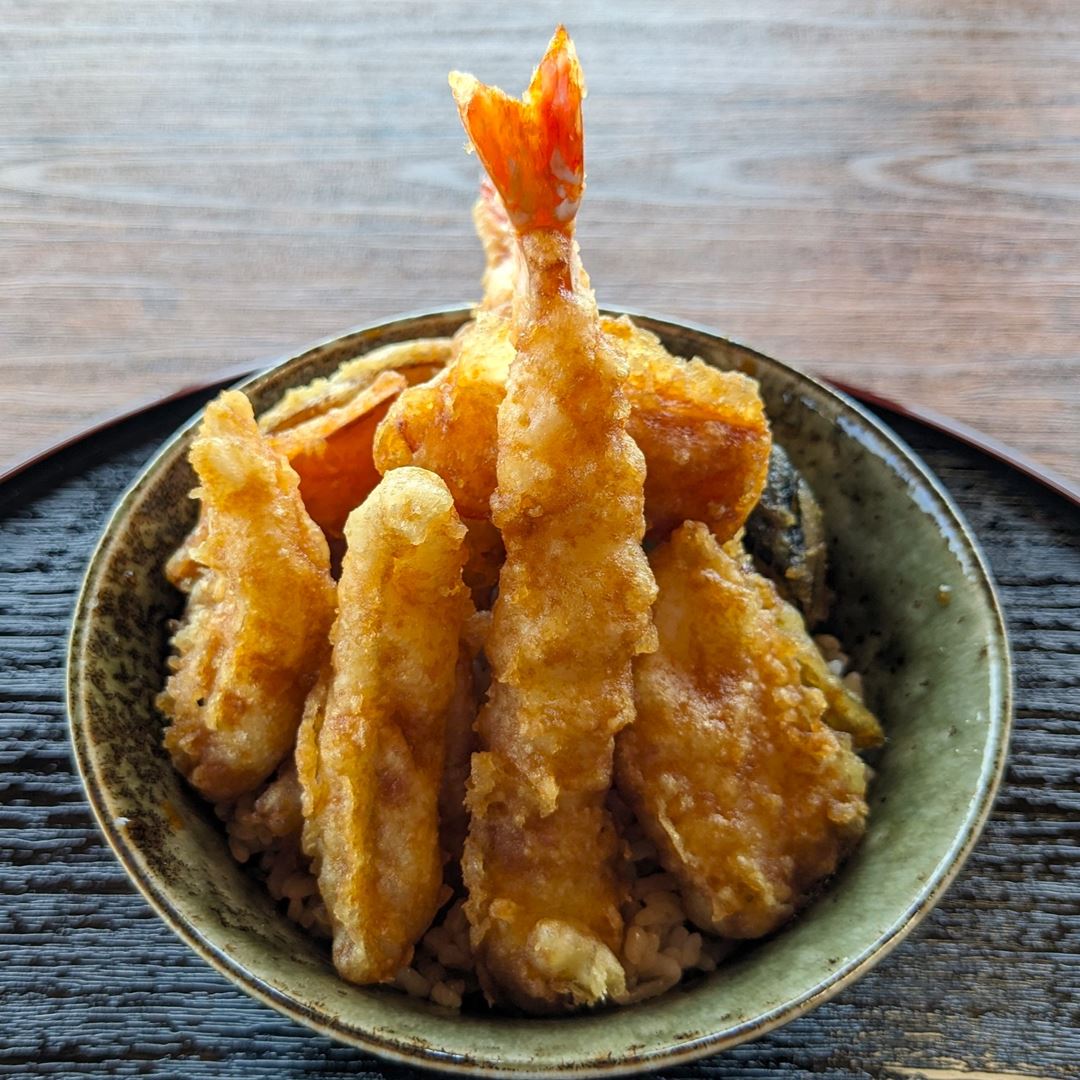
xmin=0 ymin=402 xmax=1080 ymax=1080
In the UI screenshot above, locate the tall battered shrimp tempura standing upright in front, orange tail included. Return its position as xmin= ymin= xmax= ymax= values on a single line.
xmin=449 ymin=27 xmax=654 ymax=1012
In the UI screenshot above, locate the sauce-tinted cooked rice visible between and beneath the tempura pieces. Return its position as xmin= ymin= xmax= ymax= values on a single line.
xmin=215 ymin=634 xmax=862 ymax=1009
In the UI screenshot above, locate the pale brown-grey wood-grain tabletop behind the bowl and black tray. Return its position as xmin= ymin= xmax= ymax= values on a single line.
xmin=0 ymin=0 xmax=1080 ymax=484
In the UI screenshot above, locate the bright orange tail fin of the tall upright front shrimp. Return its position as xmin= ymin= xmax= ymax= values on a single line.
xmin=450 ymin=26 xmax=585 ymax=233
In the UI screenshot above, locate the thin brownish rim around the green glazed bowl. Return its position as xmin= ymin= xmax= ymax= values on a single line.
xmin=67 ymin=306 xmax=1013 ymax=1077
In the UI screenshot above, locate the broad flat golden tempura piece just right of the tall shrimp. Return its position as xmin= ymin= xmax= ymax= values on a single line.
xmin=616 ymin=522 xmax=867 ymax=937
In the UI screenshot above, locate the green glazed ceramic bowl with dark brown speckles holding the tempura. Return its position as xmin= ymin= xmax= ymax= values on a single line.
xmin=68 ymin=309 xmax=1011 ymax=1076
